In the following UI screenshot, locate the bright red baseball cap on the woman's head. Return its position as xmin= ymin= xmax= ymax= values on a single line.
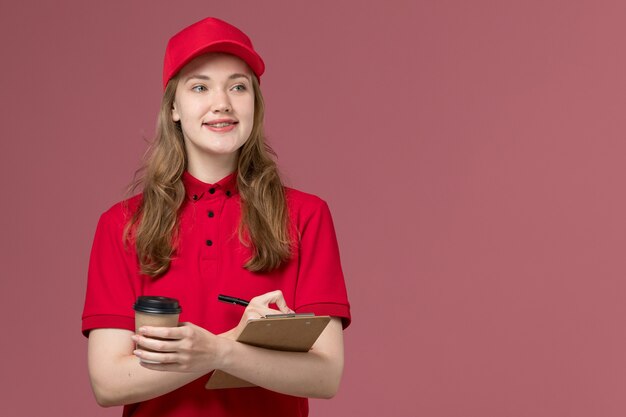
xmin=163 ymin=17 xmax=265 ymax=88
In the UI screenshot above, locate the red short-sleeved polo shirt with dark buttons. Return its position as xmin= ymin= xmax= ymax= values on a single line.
xmin=82 ymin=173 xmax=350 ymax=417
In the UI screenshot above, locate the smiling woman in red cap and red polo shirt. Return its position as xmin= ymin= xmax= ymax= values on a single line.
xmin=82 ymin=18 xmax=350 ymax=416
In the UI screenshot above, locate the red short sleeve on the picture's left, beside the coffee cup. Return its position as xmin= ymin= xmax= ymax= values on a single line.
xmin=82 ymin=205 xmax=139 ymax=336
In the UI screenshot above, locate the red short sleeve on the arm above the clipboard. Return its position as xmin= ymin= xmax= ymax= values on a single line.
xmin=295 ymin=198 xmax=352 ymax=328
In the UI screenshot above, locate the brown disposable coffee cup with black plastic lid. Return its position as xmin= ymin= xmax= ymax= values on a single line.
xmin=133 ymin=295 xmax=182 ymax=363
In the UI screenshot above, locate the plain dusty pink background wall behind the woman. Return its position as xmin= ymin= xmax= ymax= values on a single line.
xmin=0 ymin=0 xmax=626 ymax=417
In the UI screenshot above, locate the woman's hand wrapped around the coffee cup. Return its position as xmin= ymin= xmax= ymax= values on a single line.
xmin=131 ymin=323 xmax=224 ymax=373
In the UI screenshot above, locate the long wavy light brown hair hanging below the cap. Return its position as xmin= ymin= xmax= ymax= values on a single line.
xmin=125 ymin=75 xmax=291 ymax=277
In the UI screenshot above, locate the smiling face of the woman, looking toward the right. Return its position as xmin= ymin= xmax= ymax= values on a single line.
xmin=172 ymin=53 xmax=254 ymax=166
